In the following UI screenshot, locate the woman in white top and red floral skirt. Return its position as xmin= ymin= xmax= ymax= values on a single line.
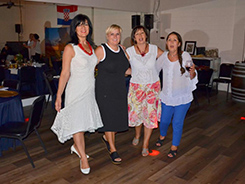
xmin=126 ymin=26 xmax=163 ymax=156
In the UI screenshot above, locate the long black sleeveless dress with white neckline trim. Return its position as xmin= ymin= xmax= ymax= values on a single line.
xmin=95 ymin=44 xmax=129 ymax=132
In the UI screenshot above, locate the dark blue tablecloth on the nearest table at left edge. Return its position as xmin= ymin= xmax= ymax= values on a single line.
xmin=0 ymin=95 xmax=24 ymax=156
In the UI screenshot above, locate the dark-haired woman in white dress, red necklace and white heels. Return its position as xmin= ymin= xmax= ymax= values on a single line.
xmin=51 ymin=14 xmax=103 ymax=174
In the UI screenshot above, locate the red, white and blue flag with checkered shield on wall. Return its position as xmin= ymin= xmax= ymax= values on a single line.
xmin=57 ymin=5 xmax=77 ymax=25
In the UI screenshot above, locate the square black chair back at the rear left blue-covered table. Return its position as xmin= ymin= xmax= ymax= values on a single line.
xmin=20 ymin=66 xmax=36 ymax=83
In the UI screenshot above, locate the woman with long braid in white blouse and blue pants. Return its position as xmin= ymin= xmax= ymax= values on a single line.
xmin=156 ymin=32 xmax=198 ymax=158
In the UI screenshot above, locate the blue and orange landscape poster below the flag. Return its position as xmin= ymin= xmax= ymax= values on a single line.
xmin=45 ymin=27 xmax=70 ymax=60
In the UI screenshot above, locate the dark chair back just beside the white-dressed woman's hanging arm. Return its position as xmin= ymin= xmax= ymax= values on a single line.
xmin=43 ymin=69 xmax=57 ymax=95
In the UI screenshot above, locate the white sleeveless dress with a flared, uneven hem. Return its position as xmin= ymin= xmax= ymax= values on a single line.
xmin=51 ymin=45 xmax=103 ymax=143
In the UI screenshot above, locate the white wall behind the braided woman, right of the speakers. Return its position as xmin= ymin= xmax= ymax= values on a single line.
xmin=153 ymin=0 xmax=245 ymax=90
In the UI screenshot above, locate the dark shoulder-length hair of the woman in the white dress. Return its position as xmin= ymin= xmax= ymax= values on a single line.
xmin=70 ymin=14 xmax=96 ymax=48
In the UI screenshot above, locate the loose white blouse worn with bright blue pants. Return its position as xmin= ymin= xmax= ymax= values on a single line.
xmin=157 ymin=52 xmax=198 ymax=106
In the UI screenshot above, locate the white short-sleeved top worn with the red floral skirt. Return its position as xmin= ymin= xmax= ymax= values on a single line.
xmin=126 ymin=44 xmax=159 ymax=84
